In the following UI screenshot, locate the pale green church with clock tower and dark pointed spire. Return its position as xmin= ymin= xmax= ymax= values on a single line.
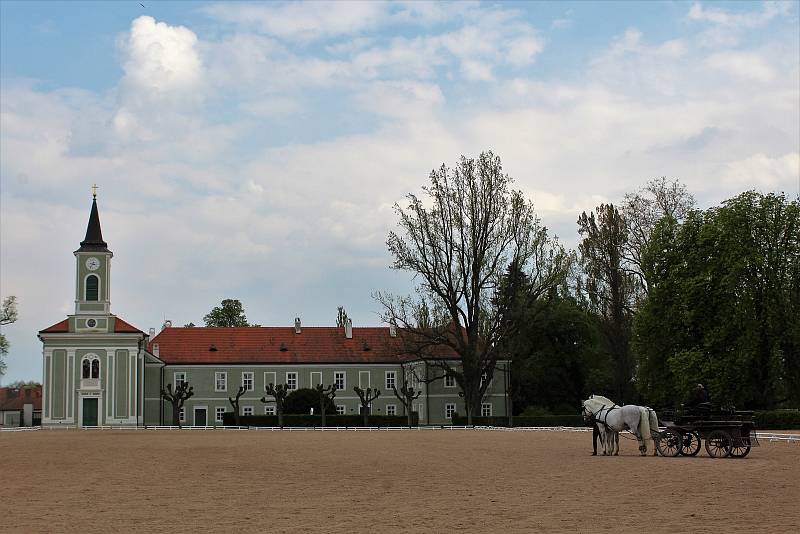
xmin=39 ymin=192 xmax=147 ymax=427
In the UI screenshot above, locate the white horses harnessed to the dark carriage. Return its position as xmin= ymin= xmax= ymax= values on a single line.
xmin=583 ymin=395 xmax=658 ymax=456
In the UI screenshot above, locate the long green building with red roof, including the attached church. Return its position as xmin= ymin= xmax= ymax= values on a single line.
xmin=39 ymin=198 xmax=508 ymax=427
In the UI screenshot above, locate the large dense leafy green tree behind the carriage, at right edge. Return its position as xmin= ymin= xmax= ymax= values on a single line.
xmin=635 ymin=191 xmax=800 ymax=408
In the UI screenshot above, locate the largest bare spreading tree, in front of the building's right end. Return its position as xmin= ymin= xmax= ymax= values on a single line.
xmin=375 ymin=152 xmax=573 ymax=424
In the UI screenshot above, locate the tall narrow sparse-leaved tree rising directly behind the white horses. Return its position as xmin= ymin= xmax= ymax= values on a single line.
xmin=578 ymin=204 xmax=642 ymax=403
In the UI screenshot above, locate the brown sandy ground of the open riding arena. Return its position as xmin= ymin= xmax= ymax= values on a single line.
xmin=0 ymin=431 xmax=800 ymax=534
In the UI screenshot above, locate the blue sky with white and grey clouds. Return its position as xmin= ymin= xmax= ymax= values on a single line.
xmin=0 ymin=0 xmax=800 ymax=383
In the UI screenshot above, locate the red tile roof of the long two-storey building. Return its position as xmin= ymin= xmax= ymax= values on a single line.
xmin=148 ymin=326 xmax=456 ymax=365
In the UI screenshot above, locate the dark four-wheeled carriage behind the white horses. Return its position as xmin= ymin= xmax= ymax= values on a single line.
xmin=653 ymin=405 xmax=758 ymax=458
